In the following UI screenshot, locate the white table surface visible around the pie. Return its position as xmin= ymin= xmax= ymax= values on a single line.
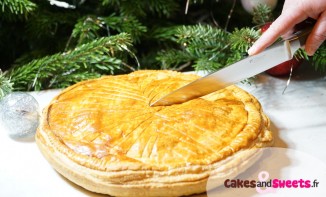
xmin=0 ymin=65 xmax=326 ymax=197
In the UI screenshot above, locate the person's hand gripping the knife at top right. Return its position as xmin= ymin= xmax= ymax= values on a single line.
xmin=248 ymin=0 xmax=326 ymax=56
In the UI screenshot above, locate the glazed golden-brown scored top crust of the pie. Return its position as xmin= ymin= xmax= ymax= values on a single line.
xmin=38 ymin=71 xmax=272 ymax=171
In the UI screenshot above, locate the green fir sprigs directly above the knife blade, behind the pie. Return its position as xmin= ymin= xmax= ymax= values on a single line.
xmin=157 ymin=25 xmax=260 ymax=71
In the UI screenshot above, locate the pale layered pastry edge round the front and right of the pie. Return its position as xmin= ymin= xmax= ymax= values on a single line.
xmin=36 ymin=70 xmax=272 ymax=196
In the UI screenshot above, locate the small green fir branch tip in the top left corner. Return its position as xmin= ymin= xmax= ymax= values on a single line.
xmin=0 ymin=0 xmax=37 ymax=21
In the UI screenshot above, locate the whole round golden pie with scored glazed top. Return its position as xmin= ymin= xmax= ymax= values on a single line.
xmin=36 ymin=71 xmax=273 ymax=196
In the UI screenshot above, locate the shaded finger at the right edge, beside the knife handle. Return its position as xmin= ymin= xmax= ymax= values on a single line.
xmin=305 ymin=11 xmax=326 ymax=56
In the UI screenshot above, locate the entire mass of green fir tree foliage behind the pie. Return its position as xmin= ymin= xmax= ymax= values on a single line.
xmin=0 ymin=0 xmax=326 ymax=90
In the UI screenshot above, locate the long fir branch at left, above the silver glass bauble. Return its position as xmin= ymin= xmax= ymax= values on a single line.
xmin=7 ymin=33 xmax=131 ymax=90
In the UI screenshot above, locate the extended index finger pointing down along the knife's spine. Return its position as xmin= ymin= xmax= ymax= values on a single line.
xmin=248 ymin=9 xmax=307 ymax=55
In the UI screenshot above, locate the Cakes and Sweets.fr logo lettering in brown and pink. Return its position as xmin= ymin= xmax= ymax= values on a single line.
xmin=224 ymin=171 xmax=319 ymax=193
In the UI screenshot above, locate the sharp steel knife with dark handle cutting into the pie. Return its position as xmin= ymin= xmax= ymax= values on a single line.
xmin=150 ymin=27 xmax=312 ymax=107
